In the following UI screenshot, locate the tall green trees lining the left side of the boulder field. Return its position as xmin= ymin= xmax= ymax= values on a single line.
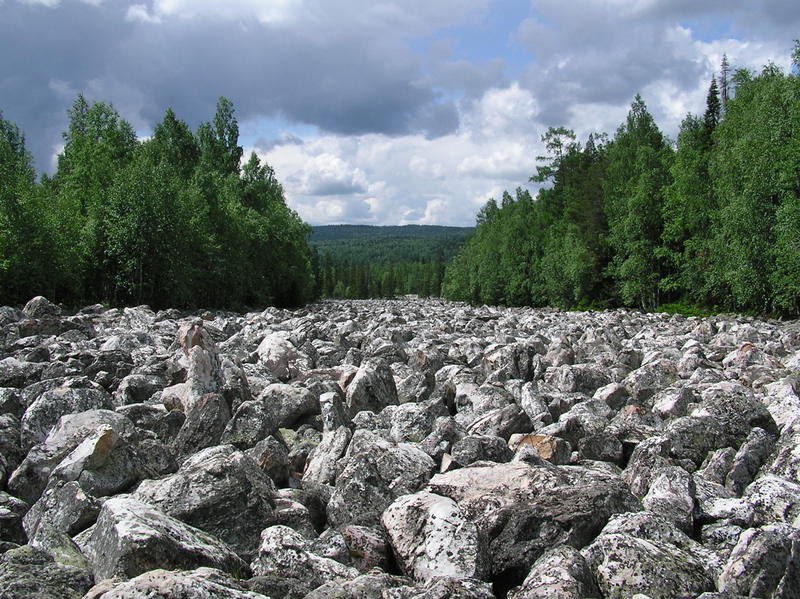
xmin=0 ymin=95 xmax=315 ymax=308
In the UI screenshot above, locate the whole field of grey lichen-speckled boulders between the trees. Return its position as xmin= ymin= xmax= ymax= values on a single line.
xmin=0 ymin=298 xmax=800 ymax=599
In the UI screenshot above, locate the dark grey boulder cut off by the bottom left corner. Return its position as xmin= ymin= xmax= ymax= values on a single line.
xmin=0 ymin=545 xmax=92 ymax=599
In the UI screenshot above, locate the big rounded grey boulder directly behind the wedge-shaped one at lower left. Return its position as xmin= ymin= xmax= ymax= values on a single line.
xmin=132 ymin=445 xmax=275 ymax=561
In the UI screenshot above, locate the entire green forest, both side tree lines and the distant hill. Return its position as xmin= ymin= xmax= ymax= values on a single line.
xmin=0 ymin=48 xmax=800 ymax=317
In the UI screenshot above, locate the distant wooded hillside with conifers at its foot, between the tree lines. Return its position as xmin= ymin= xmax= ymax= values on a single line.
xmin=311 ymin=225 xmax=474 ymax=298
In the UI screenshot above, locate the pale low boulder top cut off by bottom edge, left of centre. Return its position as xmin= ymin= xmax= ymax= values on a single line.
xmin=84 ymin=568 xmax=264 ymax=599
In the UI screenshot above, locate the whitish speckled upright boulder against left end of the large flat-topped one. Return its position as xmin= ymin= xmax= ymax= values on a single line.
xmin=382 ymin=491 xmax=489 ymax=581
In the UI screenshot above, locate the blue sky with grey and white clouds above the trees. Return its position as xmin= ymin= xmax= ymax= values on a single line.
xmin=0 ymin=0 xmax=800 ymax=225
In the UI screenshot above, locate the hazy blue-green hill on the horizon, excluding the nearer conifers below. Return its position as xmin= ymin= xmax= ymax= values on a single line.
xmin=310 ymin=225 xmax=474 ymax=264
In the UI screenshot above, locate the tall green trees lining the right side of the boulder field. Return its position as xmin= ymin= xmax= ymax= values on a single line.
xmin=443 ymin=42 xmax=800 ymax=317
